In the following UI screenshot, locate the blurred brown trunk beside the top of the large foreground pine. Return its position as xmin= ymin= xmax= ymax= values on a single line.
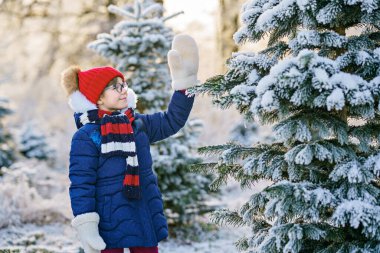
xmin=218 ymin=0 xmax=242 ymax=72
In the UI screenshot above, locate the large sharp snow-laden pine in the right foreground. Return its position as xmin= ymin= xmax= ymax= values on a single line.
xmin=192 ymin=0 xmax=380 ymax=253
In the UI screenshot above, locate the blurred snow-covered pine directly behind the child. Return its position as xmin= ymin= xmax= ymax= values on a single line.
xmin=89 ymin=0 xmax=215 ymax=238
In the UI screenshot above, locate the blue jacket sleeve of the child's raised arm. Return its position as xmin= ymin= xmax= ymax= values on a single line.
xmin=138 ymin=91 xmax=194 ymax=143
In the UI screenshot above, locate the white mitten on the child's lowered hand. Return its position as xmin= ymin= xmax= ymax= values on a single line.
xmin=71 ymin=212 xmax=106 ymax=253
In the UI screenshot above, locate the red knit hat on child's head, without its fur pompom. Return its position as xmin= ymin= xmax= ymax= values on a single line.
xmin=78 ymin=66 xmax=124 ymax=104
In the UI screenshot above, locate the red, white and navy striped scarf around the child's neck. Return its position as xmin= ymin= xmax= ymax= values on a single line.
xmin=79 ymin=108 xmax=141 ymax=199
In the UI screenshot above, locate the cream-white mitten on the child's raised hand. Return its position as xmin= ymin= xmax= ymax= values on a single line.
xmin=168 ymin=35 xmax=199 ymax=90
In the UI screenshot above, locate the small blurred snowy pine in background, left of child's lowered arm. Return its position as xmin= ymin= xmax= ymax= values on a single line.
xmin=18 ymin=122 xmax=54 ymax=160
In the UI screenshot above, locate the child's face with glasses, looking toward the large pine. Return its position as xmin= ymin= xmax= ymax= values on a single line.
xmin=97 ymin=77 xmax=128 ymax=112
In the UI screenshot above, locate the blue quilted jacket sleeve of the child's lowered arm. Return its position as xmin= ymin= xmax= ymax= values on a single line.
xmin=69 ymin=130 xmax=99 ymax=216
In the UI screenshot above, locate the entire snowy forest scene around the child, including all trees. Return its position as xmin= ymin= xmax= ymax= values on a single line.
xmin=0 ymin=0 xmax=380 ymax=253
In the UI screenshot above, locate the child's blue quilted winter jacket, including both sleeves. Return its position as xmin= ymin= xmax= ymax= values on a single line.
xmin=69 ymin=91 xmax=194 ymax=249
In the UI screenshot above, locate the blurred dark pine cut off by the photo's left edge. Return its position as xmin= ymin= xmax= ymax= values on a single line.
xmin=0 ymin=98 xmax=14 ymax=168
